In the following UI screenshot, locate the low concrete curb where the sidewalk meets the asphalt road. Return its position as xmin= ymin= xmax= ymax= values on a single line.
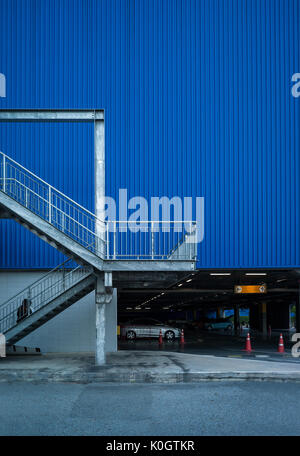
xmin=0 ymin=369 xmax=300 ymax=384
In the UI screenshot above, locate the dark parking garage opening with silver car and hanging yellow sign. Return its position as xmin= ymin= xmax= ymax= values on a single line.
xmin=118 ymin=270 xmax=299 ymax=359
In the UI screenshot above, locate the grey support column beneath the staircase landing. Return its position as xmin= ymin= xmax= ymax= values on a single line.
xmin=95 ymin=273 xmax=117 ymax=366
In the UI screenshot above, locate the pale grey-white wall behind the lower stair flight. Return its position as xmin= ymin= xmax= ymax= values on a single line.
xmin=0 ymin=271 xmax=117 ymax=353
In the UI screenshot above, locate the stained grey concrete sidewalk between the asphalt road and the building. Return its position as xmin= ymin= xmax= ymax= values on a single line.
xmin=0 ymin=351 xmax=300 ymax=383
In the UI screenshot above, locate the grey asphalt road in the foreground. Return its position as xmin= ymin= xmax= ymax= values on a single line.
xmin=0 ymin=382 xmax=300 ymax=436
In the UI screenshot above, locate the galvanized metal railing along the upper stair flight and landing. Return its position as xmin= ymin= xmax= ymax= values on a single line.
xmin=0 ymin=151 xmax=195 ymax=260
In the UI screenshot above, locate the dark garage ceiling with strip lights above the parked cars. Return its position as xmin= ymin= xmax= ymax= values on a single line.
xmin=114 ymin=270 xmax=300 ymax=312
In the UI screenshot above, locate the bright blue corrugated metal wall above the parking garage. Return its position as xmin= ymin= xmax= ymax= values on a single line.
xmin=0 ymin=0 xmax=300 ymax=268
